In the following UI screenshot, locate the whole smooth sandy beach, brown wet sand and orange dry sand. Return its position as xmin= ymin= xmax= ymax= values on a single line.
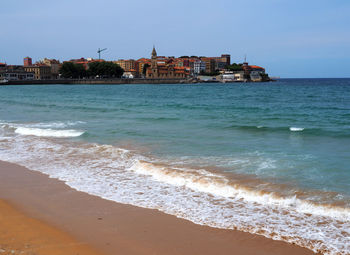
xmin=0 ymin=161 xmax=313 ymax=255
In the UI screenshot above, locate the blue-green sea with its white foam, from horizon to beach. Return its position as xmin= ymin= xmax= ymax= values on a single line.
xmin=0 ymin=79 xmax=350 ymax=255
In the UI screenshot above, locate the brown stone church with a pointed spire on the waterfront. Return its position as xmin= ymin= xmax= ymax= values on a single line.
xmin=146 ymin=47 xmax=190 ymax=79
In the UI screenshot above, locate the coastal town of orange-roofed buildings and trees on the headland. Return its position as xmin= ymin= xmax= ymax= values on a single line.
xmin=0 ymin=47 xmax=270 ymax=84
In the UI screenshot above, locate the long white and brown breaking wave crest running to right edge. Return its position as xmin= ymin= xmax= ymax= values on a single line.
xmin=134 ymin=161 xmax=350 ymax=220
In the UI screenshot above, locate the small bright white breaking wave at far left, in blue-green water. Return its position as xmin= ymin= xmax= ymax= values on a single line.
xmin=15 ymin=127 xmax=85 ymax=138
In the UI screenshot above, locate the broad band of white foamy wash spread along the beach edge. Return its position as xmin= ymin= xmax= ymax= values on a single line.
xmin=0 ymin=129 xmax=350 ymax=255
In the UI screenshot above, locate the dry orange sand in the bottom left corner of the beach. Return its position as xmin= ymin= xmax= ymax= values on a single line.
xmin=0 ymin=200 xmax=102 ymax=255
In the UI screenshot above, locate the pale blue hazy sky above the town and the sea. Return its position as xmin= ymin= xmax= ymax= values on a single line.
xmin=0 ymin=0 xmax=350 ymax=78
